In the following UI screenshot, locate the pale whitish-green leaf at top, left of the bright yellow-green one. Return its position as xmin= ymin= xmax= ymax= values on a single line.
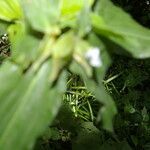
xmin=22 ymin=0 xmax=60 ymax=33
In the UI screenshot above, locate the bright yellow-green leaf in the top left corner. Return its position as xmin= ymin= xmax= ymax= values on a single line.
xmin=0 ymin=0 xmax=22 ymax=21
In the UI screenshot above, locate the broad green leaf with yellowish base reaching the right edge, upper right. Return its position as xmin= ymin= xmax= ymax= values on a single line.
xmin=92 ymin=0 xmax=150 ymax=58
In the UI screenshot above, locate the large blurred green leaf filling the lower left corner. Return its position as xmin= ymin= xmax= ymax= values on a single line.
xmin=0 ymin=63 xmax=66 ymax=150
